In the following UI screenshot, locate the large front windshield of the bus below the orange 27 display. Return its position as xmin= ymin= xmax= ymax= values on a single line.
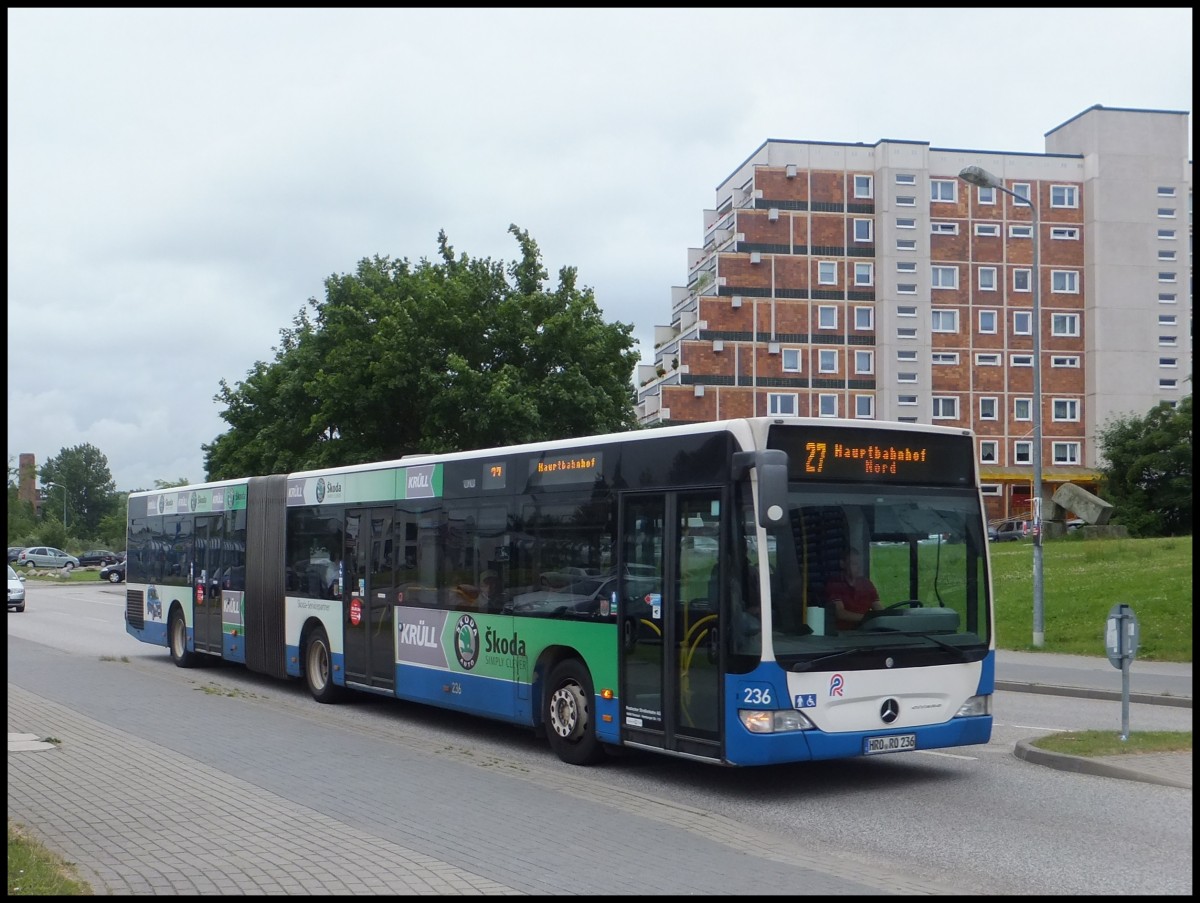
xmin=744 ymin=484 xmax=990 ymax=668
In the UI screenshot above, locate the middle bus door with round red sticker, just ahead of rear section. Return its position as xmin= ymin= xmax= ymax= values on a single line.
xmin=342 ymin=507 xmax=396 ymax=690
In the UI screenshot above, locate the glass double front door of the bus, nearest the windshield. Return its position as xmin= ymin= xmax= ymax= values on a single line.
xmin=618 ymin=490 xmax=721 ymax=759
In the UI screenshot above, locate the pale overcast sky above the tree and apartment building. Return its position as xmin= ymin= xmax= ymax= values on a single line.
xmin=8 ymin=8 xmax=1193 ymax=490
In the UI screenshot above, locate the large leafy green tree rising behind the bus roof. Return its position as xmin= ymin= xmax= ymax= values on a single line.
xmin=204 ymin=226 xmax=637 ymax=479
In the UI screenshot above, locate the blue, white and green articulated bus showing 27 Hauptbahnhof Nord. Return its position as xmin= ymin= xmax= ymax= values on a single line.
xmin=126 ymin=418 xmax=995 ymax=766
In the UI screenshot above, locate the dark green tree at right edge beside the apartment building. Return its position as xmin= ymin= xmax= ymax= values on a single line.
xmin=1098 ymin=395 xmax=1192 ymax=537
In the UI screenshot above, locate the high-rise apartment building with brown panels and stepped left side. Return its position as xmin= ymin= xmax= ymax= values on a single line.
xmin=638 ymin=106 xmax=1192 ymax=518
